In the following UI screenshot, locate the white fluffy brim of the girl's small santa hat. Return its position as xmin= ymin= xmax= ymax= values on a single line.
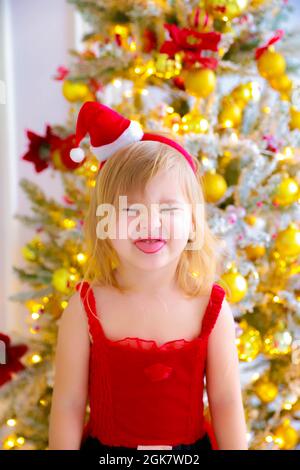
xmin=90 ymin=121 xmax=144 ymax=161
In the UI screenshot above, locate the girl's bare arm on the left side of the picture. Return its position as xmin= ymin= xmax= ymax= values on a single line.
xmin=48 ymin=292 xmax=90 ymax=450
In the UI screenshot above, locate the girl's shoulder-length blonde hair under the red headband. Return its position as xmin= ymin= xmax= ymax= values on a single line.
xmin=83 ymin=131 xmax=226 ymax=297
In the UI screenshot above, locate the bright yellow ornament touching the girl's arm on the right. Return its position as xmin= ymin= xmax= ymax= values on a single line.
xmin=236 ymin=320 xmax=262 ymax=362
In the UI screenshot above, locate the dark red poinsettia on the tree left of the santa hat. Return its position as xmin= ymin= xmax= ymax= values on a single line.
xmin=22 ymin=125 xmax=82 ymax=173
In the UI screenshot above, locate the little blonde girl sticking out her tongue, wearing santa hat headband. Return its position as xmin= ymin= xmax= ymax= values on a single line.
xmin=49 ymin=102 xmax=247 ymax=452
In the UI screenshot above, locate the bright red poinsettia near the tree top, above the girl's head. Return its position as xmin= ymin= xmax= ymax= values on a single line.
xmin=160 ymin=24 xmax=221 ymax=69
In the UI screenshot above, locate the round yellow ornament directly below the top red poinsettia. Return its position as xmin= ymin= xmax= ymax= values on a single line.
xmin=183 ymin=69 xmax=217 ymax=98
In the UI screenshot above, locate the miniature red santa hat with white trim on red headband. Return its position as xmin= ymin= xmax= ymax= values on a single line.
xmin=70 ymin=101 xmax=196 ymax=172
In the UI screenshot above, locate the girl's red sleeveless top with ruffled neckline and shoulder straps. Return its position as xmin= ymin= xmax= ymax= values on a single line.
xmin=76 ymin=281 xmax=225 ymax=450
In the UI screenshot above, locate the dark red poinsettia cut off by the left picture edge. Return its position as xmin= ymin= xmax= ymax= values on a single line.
xmin=0 ymin=333 xmax=28 ymax=386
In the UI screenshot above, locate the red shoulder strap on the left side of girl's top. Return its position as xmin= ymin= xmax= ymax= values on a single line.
xmin=75 ymin=281 xmax=102 ymax=342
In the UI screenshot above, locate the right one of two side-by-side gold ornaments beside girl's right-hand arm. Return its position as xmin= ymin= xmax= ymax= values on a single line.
xmin=263 ymin=322 xmax=293 ymax=357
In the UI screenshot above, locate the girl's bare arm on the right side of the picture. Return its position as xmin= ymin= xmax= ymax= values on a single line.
xmin=206 ymin=299 xmax=248 ymax=450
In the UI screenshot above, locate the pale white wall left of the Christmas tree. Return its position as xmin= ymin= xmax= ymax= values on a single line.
xmin=0 ymin=0 xmax=76 ymax=333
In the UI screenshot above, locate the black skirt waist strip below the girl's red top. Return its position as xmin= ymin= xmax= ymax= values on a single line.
xmin=80 ymin=433 xmax=212 ymax=454
